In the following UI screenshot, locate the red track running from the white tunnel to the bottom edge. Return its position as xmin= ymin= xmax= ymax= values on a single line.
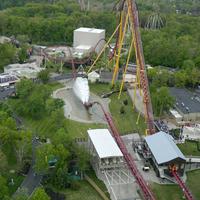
xmin=92 ymin=102 xmax=155 ymax=200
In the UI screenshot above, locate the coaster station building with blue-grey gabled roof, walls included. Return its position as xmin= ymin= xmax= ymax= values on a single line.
xmin=144 ymin=132 xmax=186 ymax=179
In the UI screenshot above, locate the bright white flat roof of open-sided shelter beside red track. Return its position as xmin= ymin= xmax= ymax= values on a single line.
xmin=87 ymin=129 xmax=123 ymax=158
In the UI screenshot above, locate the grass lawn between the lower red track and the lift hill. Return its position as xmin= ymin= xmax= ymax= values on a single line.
xmin=90 ymin=84 xmax=146 ymax=135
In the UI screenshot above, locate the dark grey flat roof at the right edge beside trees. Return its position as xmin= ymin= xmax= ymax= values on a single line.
xmin=170 ymin=87 xmax=200 ymax=114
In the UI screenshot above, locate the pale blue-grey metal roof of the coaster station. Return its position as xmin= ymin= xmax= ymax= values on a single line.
xmin=145 ymin=131 xmax=185 ymax=164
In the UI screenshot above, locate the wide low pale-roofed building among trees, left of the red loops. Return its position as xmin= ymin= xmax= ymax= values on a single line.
xmin=4 ymin=62 xmax=45 ymax=79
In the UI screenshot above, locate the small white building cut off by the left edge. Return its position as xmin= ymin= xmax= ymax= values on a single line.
xmin=0 ymin=73 xmax=19 ymax=87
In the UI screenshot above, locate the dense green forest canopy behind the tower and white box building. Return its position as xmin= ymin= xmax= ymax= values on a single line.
xmin=0 ymin=0 xmax=200 ymax=68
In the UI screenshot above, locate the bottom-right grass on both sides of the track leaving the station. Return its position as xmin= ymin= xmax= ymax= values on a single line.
xmin=152 ymin=170 xmax=200 ymax=200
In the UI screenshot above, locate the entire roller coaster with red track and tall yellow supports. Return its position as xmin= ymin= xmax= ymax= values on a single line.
xmin=74 ymin=0 xmax=193 ymax=200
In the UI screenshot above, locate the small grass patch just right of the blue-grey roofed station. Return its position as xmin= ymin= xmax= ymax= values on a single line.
xmin=178 ymin=140 xmax=200 ymax=156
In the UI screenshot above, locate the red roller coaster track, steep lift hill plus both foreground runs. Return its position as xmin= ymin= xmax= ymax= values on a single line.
xmin=86 ymin=0 xmax=193 ymax=200
